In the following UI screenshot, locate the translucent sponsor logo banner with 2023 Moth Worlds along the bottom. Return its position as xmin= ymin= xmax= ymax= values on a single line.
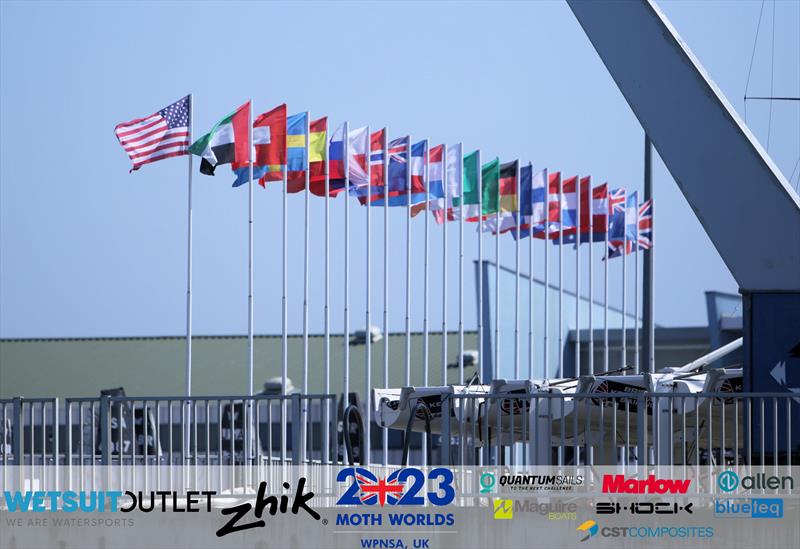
xmin=0 ymin=465 xmax=800 ymax=549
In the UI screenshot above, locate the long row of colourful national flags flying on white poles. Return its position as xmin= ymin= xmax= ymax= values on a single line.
xmin=115 ymin=96 xmax=653 ymax=258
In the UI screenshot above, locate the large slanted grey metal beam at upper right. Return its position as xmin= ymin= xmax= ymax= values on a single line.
xmin=568 ymin=0 xmax=800 ymax=292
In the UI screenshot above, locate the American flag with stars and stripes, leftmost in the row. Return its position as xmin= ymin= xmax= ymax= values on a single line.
xmin=114 ymin=95 xmax=192 ymax=171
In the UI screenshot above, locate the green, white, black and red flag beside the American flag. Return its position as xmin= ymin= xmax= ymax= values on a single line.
xmin=189 ymin=101 xmax=250 ymax=175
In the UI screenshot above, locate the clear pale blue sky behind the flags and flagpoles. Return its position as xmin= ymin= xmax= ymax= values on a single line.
xmin=0 ymin=1 xmax=800 ymax=337
